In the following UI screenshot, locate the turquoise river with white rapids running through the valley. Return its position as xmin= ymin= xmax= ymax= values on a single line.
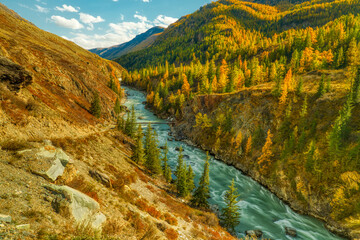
xmin=123 ymin=87 xmax=342 ymax=240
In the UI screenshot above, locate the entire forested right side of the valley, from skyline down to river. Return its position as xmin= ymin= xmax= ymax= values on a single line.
xmin=118 ymin=0 xmax=360 ymax=239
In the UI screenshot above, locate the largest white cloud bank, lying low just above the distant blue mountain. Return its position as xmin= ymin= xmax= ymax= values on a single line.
xmin=63 ymin=12 xmax=177 ymax=49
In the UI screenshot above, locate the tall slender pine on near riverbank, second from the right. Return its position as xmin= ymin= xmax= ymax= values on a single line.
xmin=191 ymin=153 xmax=210 ymax=209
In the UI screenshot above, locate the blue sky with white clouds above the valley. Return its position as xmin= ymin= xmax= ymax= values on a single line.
xmin=1 ymin=0 xmax=211 ymax=49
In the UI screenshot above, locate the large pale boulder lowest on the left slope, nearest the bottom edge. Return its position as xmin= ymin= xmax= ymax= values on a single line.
xmin=45 ymin=185 xmax=106 ymax=229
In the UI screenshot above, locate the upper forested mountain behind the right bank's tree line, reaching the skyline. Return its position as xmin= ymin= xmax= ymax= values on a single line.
xmin=116 ymin=0 xmax=360 ymax=70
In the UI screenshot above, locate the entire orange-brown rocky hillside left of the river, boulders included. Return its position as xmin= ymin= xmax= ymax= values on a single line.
xmin=0 ymin=4 xmax=238 ymax=240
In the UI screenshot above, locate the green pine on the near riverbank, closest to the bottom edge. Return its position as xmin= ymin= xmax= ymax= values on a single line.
xmin=221 ymin=179 xmax=240 ymax=234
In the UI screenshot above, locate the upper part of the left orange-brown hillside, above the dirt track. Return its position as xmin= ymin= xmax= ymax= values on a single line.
xmin=0 ymin=2 xmax=124 ymax=140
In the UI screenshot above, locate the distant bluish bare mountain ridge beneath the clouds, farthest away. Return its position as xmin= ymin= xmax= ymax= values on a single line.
xmin=89 ymin=27 xmax=164 ymax=59
